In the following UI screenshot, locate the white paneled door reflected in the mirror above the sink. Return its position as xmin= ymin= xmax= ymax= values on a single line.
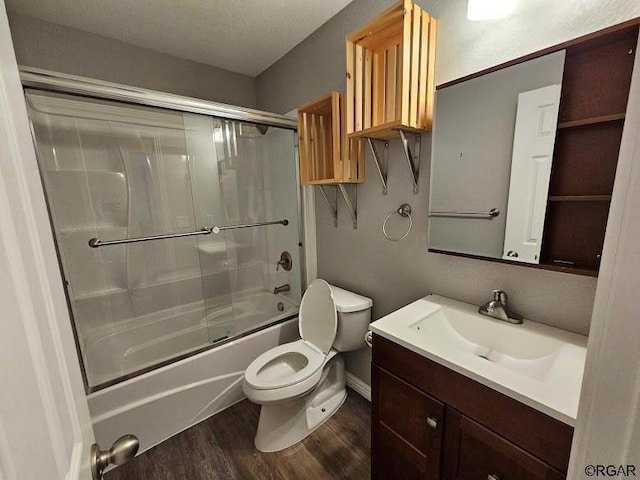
xmin=502 ymin=85 xmax=560 ymax=263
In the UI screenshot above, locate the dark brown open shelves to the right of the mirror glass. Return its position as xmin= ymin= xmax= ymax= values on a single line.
xmin=540 ymin=24 xmax=638 ymax=275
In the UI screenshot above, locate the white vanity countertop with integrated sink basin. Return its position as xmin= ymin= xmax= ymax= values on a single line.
xmin=370 ymin=295 xmax=587 ymax=425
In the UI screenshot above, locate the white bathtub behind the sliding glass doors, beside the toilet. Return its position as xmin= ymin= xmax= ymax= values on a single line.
xmin=87 ymin=292 xmax=298 ymax=451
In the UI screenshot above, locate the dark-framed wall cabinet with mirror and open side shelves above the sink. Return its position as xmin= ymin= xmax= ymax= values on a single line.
xmin=428 ymin=25 xmax=638 ymax=275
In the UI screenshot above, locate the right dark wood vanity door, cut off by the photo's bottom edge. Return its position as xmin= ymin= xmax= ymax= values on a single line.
xmin=442 ymin=408 xmax=565 ymax=480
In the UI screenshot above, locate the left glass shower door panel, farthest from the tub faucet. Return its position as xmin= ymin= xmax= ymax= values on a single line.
xmin=26 ymin=90 xmax=232 ymax=388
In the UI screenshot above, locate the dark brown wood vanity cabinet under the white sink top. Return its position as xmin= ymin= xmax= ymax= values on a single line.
xmin=371 ymin=334 xmax=573 ymax=480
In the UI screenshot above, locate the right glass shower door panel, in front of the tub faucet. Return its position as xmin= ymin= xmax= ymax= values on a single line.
xmin=185 ymin=114 xmax=301 ymax=341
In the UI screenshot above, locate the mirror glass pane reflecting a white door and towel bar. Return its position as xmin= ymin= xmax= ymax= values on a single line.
xmin=429 ymin=50 xmax=566 ymax=263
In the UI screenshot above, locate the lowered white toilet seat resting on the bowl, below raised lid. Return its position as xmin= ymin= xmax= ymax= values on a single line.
xmin=244 ymin=340 xmax=326 ymax=390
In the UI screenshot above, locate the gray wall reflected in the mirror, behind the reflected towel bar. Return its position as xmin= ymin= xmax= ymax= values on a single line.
xmin=429 ymin=50 xmax=565 ymax=258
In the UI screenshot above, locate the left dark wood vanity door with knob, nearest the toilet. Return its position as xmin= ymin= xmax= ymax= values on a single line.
xmin=371 ymin=365 xmax=444 ymax=480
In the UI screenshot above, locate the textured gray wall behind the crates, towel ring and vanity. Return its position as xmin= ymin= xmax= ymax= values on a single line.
xmin=251 ymin=0 xmax=640 ymax=382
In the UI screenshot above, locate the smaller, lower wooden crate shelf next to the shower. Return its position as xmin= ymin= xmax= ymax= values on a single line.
xmin=298 ymin=92 xmax=364 ymax=185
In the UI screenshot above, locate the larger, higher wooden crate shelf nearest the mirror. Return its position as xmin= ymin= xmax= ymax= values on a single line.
xmin=346 ymin=0 xmax=436 ymax=140
